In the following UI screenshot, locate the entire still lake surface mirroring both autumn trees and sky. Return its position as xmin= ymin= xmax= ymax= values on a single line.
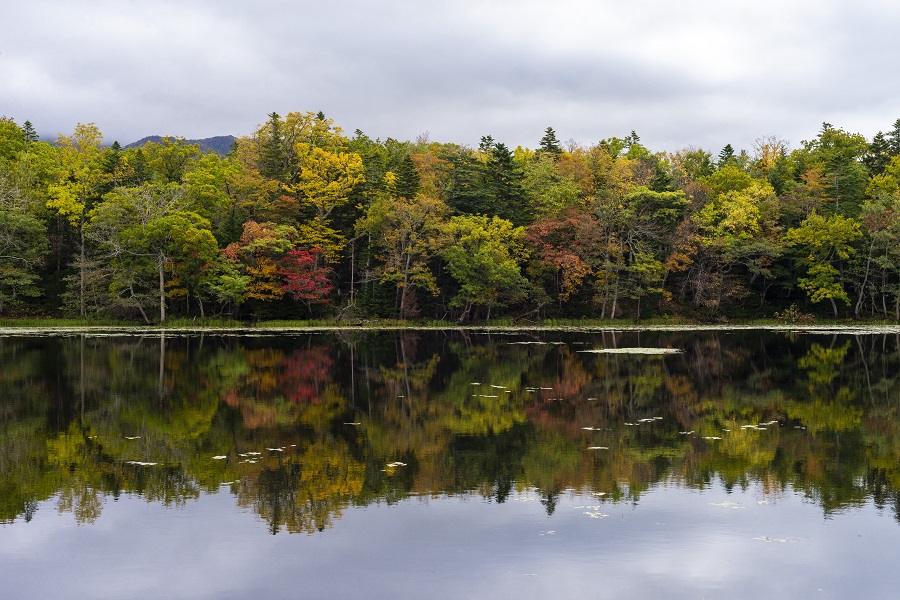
xmin=0 ymin=330 xmax=900 ymax=599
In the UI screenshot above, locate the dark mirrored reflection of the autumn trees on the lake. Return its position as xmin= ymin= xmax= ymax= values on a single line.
xmin=0 ymin=331 xmax=900 ymax=533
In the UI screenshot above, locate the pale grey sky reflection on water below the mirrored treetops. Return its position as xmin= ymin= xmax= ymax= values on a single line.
xmin=0 ymin=484 xmax=900 ymax=599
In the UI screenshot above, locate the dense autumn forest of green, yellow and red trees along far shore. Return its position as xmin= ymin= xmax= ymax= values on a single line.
xmin=0 ymin=112 xmax=900 ymax=323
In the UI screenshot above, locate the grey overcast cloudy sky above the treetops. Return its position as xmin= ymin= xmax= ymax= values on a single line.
xmin=0 ymin=0 xmax=900 ymax=153
